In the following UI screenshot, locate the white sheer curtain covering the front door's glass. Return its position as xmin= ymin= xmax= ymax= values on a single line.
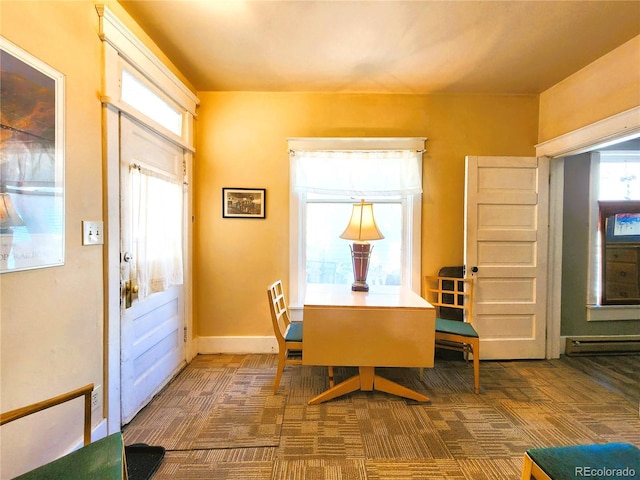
xmin=130 ymin=165 xmax=183 ymax=299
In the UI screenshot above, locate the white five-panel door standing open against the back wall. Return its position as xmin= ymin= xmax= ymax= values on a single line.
xmin=465 ymin=157 xmax=549 ymax=359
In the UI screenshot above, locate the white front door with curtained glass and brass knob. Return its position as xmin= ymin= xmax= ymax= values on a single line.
xmin=120 ymin=115 xmax=186 ymax=425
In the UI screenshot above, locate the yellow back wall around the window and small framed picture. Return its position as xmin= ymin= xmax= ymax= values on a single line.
xmin=194 ymin=92 xmax=538 ymax=337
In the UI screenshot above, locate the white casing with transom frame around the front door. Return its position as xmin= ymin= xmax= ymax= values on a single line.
xmin=99 ymin=4 xmax=200 ymax=432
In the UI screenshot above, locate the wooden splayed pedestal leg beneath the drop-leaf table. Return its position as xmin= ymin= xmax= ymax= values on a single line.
xmin=309 ymin=367 xmax=431 ymax=405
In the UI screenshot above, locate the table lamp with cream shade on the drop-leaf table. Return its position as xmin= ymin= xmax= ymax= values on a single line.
xmin=340 ymin=200 xmax=384 ymax=292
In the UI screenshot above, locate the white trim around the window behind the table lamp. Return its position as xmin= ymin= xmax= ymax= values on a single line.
xmin=287 ymin=137 xmax=427 ymax=320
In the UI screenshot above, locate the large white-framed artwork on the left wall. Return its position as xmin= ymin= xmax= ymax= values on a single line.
xmin=0 ymin=37 xmax=65 ymax=273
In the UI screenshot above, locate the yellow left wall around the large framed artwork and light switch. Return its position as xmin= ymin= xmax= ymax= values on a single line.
xmin=0 ymin=0 xmax=191 ymax=479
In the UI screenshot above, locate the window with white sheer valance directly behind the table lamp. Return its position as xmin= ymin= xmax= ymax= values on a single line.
xmin=289 ymin=139 xmax=424 ymax=309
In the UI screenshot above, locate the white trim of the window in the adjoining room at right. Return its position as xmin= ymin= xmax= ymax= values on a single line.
xmin=586 ymin=151 xmax=640 ymax=322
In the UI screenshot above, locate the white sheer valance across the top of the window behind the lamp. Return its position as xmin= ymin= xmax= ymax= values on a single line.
xmin=291 ymin=150 xmax=422 ymax=197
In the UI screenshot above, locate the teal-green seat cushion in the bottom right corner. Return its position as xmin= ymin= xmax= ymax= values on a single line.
xmin=527 ymin=443 xmax=640 ymax=480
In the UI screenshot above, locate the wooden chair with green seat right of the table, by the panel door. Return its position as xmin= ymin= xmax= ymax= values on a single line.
xmin=420 ymin=276 xmax=480 ymax=393
